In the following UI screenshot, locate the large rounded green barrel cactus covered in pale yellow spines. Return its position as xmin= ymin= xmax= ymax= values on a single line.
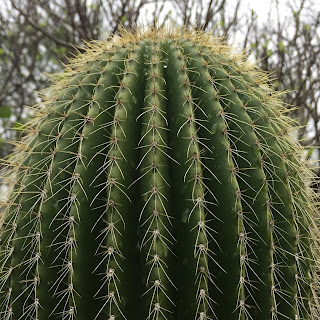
xmin=0 ymin=28 xmax=320 ymax=320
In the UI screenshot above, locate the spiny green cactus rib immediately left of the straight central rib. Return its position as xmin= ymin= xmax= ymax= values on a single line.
xmin=94 ymin=42 xmax=145 ymax=319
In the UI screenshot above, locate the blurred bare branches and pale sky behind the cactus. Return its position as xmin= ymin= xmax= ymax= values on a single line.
xmin=0 ymin=0 xmax=320 ymax=193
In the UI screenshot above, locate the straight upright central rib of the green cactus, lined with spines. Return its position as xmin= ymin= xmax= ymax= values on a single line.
xmin=134 ymin=41 xmax=175 ymax=320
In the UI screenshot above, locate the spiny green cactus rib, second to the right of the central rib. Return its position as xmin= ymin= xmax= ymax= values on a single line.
xmin=184 ymin=41 xmax=246 ymax=319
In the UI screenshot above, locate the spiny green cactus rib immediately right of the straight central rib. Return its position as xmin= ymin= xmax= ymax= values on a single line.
xmin=166 ymin=41 xmax=215 ymax=319
